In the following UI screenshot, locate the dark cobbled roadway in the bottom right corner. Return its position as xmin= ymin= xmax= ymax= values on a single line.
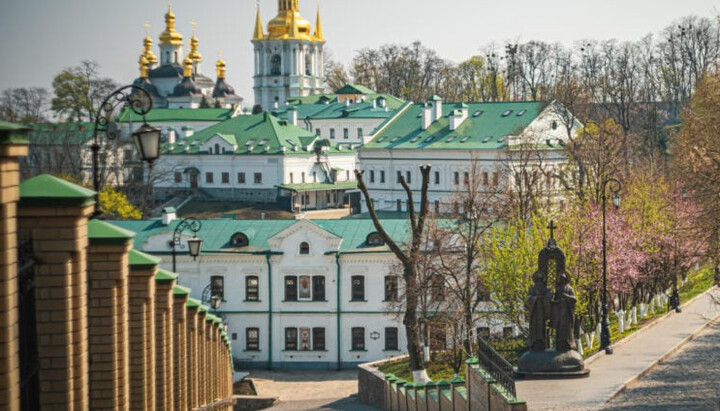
xmin=602 ymin=323 xmax=720 ymax=411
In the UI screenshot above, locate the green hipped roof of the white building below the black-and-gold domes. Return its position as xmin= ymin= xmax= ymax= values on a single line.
xmin=162 ymin=113 xmax=356 ymax=156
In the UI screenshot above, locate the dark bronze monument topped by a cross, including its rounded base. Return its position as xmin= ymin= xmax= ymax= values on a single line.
xmin=516 ymin=221 xmax=590 ymax=378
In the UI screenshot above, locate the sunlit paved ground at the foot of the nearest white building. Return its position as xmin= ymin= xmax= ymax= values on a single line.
xmin=248 ymin=370 xmax=375 ymax=411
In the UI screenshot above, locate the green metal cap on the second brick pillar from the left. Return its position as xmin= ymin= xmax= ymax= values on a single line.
xmin=20 ymin=174 xmax=95 ymax=206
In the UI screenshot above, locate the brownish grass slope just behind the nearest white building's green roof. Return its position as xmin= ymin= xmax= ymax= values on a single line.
xmin=179 ymin=199 xmax=294 ymax=220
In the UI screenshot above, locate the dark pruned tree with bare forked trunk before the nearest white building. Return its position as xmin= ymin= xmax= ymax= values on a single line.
xmin=355 ymin=164 xmax=431 ymax=381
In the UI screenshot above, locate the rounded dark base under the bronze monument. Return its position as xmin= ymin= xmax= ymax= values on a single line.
xmin=515 ymin=349 xmax=590 ymax=379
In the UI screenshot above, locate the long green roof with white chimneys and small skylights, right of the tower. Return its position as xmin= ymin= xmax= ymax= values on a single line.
xmin=364 ymin=102 xmax=547 ymax=150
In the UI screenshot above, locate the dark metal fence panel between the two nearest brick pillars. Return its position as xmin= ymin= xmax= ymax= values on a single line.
xmin=18 ymin=240 xmax=40 ymax=410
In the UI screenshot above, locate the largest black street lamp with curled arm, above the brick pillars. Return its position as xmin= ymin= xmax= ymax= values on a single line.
xmin=90 ymin=85 xmax=160 ymax=217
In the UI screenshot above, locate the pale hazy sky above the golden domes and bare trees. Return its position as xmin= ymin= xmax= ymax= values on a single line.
xmin=0 ymin=0 xmax=720 ymax=104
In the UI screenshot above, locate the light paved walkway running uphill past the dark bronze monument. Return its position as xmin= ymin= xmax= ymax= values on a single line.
xmin=517 ymin=287 xmax=720 ymax=410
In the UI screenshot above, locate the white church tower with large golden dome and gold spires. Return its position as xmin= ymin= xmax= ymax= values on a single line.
xmin=252 ymin=0 xmax=325 ymax=110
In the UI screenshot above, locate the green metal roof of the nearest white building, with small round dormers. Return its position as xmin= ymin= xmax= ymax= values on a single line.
xmin=106 ymin=218 xmax=410 ymax=253
